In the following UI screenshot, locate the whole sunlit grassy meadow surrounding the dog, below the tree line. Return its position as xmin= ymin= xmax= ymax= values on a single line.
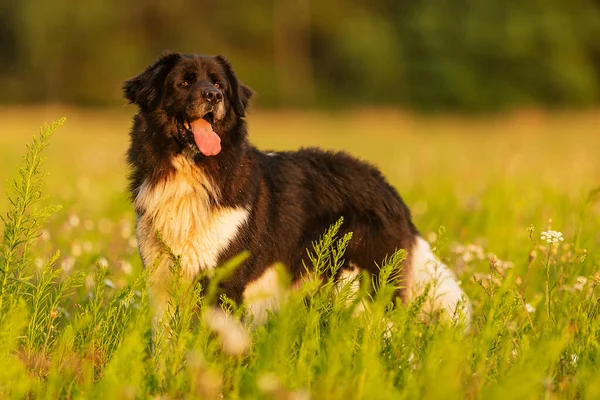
xmin=0 ymin=108 xmax=600 ymax=399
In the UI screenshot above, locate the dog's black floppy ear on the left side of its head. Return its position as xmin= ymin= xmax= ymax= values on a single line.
xmin=123 ymin=52 xmax=181 ymax=111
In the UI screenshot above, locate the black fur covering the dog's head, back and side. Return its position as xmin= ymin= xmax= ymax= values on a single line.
xmin=124 ymin=53 xmax=418 ymax=301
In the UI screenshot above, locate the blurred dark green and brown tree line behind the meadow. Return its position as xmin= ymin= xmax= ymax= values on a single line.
xmin=0 ymin=0 xmax=600 ymax=110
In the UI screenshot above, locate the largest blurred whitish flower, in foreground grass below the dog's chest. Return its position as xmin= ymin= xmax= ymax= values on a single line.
xmin=204 ymin=307 xmax=250 ymax=355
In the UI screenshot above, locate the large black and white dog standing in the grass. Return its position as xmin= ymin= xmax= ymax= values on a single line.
xmin=123 ymin=52 xmax=471 ymax=321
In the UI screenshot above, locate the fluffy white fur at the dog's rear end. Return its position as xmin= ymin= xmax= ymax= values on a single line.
xmin=408 ymin=236 xmax=472 ymax=329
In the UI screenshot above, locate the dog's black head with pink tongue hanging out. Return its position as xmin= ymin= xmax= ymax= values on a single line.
xmin=123 ymin=53 xmax=252 ymax=156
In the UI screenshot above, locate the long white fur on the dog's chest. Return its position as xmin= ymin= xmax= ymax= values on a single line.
xmin=135 ymin=156 xmax=249 ymax=279
